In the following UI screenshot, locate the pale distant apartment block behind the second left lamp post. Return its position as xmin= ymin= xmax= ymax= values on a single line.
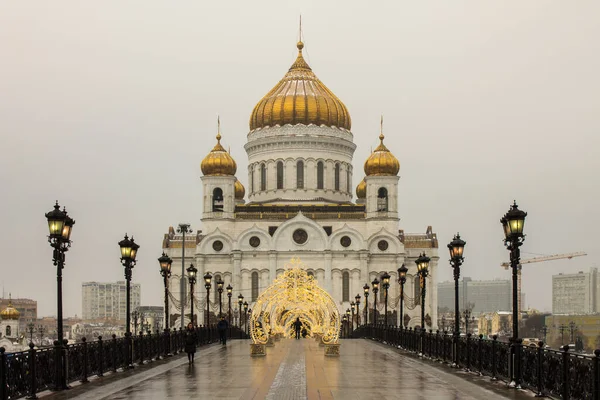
xmin=81 ymin=281 xmax=141 ymax=321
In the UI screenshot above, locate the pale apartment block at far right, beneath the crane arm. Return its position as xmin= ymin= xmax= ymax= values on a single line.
xmin=552 ymin=267 xmax=600 ymax=315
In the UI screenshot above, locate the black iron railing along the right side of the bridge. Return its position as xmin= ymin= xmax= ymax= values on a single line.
xmin=351 ymin=325 xmax=600 ymax=400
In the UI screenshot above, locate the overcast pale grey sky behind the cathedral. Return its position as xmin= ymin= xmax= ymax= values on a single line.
xmin=0 ymin=0 xmax=600 ymax=315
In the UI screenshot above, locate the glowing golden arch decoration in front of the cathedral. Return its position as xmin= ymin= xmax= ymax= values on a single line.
xmin=250 ymin=258 xmax=341 ymax=345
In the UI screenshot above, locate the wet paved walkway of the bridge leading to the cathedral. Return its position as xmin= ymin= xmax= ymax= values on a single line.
xmin=42 ymin=339 xmax=533 ymax=400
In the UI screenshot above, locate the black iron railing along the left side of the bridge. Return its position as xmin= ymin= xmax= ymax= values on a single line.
xmin=0 ymin=326 xmax=247 ymax=400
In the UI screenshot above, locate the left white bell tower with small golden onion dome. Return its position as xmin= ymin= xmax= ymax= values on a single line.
xmin=200 ymin=122 xmax=245 ymax=219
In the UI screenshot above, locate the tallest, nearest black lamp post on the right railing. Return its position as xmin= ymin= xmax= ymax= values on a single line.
xmin=500 ymin=201 xmax=527 ymax=389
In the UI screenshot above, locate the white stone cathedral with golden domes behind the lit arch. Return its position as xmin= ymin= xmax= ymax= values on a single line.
xmin=162 ymin=42 xmax=438 ymax=328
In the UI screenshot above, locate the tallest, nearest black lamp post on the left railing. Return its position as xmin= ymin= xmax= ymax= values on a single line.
xmin=46 ymin=201 xmax=75 ymax=390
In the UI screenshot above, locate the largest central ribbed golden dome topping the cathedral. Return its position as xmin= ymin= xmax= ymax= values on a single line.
xmin=250 ymin=42 xmax=351 ymax=131
